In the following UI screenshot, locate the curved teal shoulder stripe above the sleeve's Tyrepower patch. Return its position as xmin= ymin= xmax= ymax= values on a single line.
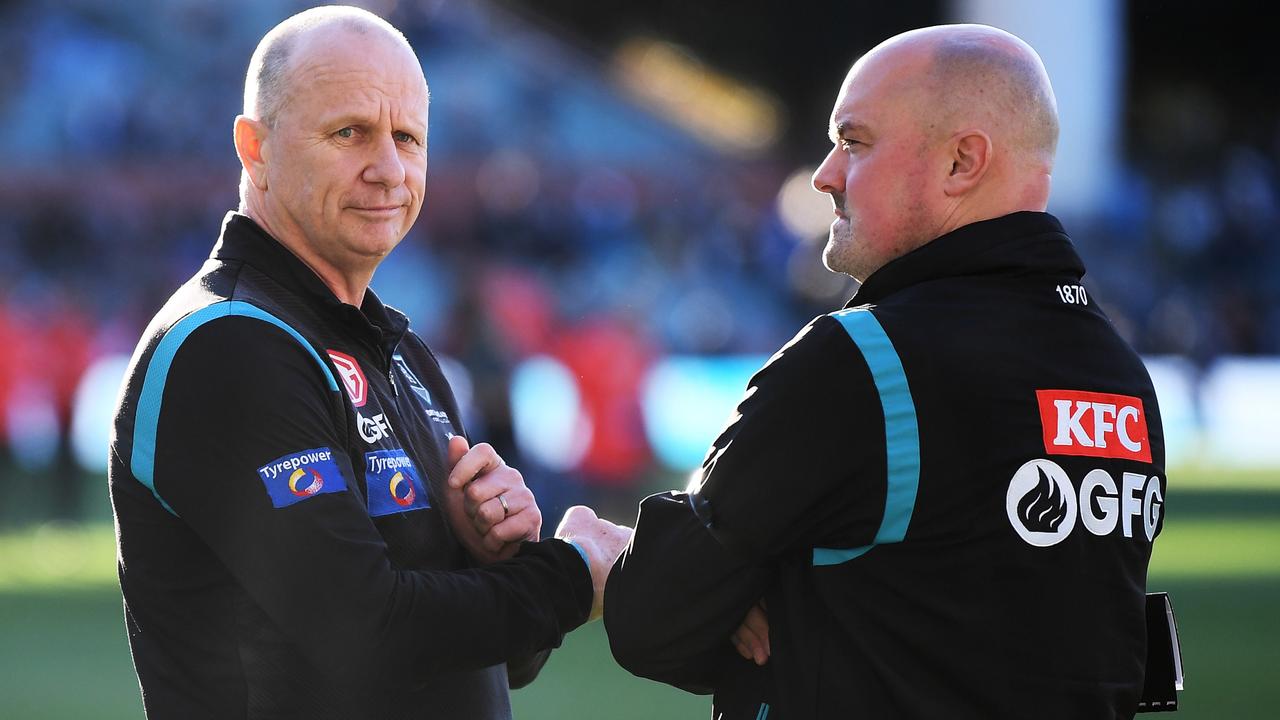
xmin=129 ymin=300 xmax=338 ymax=515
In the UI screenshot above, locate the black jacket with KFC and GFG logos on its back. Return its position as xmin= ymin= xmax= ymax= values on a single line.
xmin=604 ymin=213 xmax=1166 ymax=720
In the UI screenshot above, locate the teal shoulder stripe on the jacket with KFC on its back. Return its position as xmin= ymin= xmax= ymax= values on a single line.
xmin=813 ymin=307 xmax=920 ymax=565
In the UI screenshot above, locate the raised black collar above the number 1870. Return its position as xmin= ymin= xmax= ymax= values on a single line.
xmin=845 ymin=211 xmax=1084 ymax=307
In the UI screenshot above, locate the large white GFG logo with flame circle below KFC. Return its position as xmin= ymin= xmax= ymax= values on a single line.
xmin=1005 ymin=459 xmax=1165 ymax=547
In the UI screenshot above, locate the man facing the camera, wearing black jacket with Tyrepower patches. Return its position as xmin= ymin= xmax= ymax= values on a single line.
xmin=110 ymin=8 xmax=627 ymax=720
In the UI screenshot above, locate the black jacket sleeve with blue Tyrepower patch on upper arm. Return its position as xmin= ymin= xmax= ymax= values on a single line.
xmin=155 ymin=316 xmax=591 ymax=683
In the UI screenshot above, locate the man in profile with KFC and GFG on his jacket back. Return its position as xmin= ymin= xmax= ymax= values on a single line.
xmin=604 ymin=26 xmax=1165 ymax=720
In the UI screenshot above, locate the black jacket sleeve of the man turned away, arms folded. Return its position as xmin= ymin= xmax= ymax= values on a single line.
xmin=604 ymin=316 xmax=886 ymax=692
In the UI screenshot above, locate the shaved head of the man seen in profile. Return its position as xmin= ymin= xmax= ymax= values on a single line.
xmin=814 ymin=24 xmax=1059 ymax=279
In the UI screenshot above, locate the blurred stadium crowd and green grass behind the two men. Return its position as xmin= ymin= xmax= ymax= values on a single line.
xmin=0 ymin=0 xmax=1280 ymax=719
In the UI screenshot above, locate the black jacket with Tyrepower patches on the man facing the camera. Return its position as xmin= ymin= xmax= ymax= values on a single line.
xmin=110 ymin=213 xmax=591 ymax=720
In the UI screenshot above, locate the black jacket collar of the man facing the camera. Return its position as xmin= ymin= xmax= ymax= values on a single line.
xmin=209 ymin=211 xmax=408 ymax=355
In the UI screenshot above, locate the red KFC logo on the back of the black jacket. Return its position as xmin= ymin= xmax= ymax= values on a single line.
xmin=1036 ymin=389 xmax=1151 ymax=462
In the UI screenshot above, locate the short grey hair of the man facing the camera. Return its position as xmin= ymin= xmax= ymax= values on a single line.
xmin=244 ymin=5 xmax=412 ymax=128
